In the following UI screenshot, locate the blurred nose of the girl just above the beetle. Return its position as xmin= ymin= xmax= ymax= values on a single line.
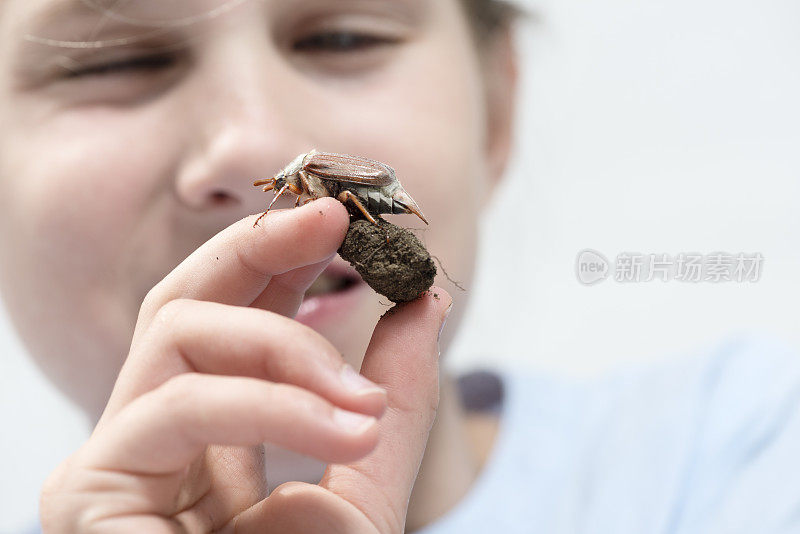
xmin=175 ymin=43 xmax=308 ymax=216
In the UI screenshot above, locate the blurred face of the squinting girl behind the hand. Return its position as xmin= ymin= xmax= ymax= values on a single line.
xmin=0 ymin=0 xmax=508 ymax=414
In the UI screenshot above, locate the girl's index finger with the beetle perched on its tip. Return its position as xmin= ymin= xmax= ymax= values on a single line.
xmin=134 ymin=197 xmax=349 ymax=341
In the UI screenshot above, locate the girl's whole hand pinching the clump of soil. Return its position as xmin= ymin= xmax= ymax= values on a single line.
xmin=41 ymin=199 xmax=451 ymax=534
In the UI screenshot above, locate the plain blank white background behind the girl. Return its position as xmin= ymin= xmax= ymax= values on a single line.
xmin=0 ymin=0 xmax=800 ymax=532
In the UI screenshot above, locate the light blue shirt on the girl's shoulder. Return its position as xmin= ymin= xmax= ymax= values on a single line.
xmin=417 ymin=334 xmax=800 ymax=534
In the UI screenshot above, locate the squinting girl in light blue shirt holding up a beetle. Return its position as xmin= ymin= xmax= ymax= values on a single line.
xmin=0 ymin=0 xmax=800 ymax=534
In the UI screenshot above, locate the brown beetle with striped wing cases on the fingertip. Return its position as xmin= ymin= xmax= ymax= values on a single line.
xmin=253 ymin=150 xmax=428 ymax=227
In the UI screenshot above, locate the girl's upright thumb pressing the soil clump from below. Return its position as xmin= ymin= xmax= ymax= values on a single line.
xmin=320 ymin=286 xmax=452 ymax=532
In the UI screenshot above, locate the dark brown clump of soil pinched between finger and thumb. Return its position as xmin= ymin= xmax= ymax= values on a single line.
xmin=339 ymin=219 xmax=436 ymax=302
